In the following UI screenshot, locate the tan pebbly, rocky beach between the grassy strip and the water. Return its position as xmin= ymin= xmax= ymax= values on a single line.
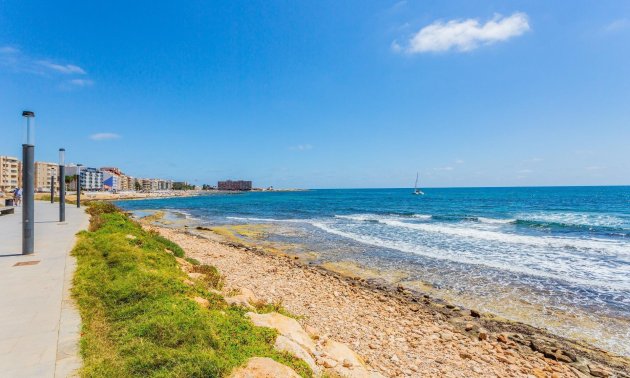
xmin=144 ymin=222 xmax=630 ymax=377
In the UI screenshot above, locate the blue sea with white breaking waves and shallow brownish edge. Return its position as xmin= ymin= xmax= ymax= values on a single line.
xmin=117 ymin=186 xmax=630 ymax=356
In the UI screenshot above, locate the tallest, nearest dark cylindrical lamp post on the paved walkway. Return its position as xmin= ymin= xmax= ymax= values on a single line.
xmin=22 ymin=110 xmax=35 ymax=255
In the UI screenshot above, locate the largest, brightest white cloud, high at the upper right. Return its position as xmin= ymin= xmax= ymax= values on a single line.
xmin=402 ymin=12 xmax=530 ymax=54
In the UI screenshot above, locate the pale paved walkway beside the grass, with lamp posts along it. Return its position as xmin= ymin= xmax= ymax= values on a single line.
xmin=0 ymin=201 xmax=88 ymax=378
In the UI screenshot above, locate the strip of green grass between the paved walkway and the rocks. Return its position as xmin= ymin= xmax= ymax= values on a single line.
xmin=73 ymin=203 xmax=312 ymax=377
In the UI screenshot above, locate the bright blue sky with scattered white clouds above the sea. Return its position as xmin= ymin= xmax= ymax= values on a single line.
xmin=0 ymin=0 xmax=630 ymax=188
